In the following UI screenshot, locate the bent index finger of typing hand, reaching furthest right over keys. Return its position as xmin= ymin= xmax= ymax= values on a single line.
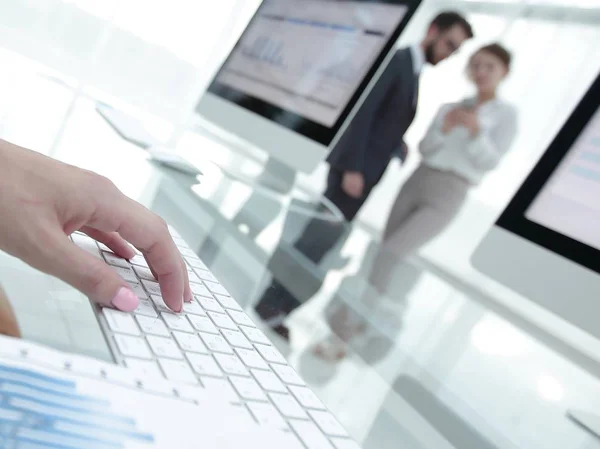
xmin=88 ymin=188 xmax=185 ymax=312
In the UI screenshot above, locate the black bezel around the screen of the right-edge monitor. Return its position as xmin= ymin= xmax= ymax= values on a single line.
xmin=496 ymin=74 xmax=600 ymax=274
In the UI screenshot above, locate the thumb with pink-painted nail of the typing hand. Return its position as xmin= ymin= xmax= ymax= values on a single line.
xmin=40 ymin=233 xmax=139 ymax=312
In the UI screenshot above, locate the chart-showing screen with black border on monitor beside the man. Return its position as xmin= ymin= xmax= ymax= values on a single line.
xmin=204 ymin=0 xmax=418 ymax=145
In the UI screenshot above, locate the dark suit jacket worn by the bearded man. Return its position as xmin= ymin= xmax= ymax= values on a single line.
xmin=327 ymin=48 xmax=418 ymax=185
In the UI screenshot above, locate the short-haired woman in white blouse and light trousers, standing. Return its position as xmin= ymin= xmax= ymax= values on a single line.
xmin=315 ymin=44 xmax=517 ymax=360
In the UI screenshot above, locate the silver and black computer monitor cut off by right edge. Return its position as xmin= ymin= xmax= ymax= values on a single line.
xmin=472 ymin=75 xmax=600 ymax=437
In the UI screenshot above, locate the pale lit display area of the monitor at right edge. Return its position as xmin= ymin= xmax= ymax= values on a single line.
xmin=525 ymin=107 xmax=600 ymax=250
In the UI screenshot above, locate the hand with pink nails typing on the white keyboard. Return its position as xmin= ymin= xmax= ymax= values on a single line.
xmin=0 ymin=140 xmax=192 ymax=312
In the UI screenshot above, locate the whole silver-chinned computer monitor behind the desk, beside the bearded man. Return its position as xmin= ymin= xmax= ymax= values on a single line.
xmin=196 ymin=0 xmax=420 ymax=172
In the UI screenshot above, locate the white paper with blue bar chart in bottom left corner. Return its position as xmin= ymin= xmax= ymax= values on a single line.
xmin=0 ymin=337 xmax=296 ymax=449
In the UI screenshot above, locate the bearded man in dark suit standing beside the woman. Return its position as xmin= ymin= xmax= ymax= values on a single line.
xmin=255 ymin=11 xmax=473 ymax=339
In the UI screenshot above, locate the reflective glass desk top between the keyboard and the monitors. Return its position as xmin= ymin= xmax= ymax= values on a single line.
xmin=0 ymin=90 xmax=600 ymax=449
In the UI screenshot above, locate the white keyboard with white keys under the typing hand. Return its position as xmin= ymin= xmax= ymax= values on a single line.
xmin=72 ymin=229 xmax=359 ymax=449
